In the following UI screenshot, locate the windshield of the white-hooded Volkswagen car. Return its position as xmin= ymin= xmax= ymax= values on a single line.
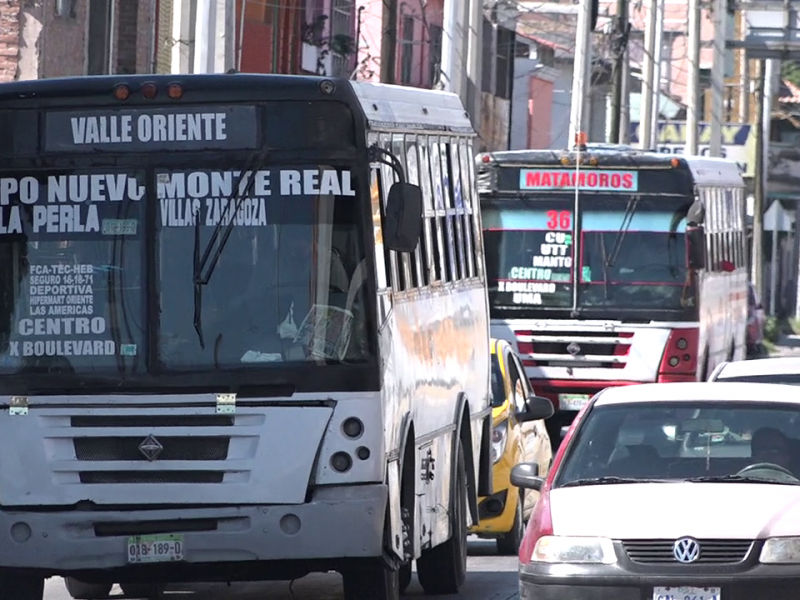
xmin=555 ymin=401 xmax=800 ymax=487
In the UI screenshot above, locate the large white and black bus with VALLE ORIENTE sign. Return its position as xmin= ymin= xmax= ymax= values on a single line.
xmin=0 ymin=74 xmax=544 ymax=600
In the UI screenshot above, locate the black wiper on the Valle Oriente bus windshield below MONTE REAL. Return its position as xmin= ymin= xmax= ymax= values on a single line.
xmin=193 ymin=151 xmax=267 ymax=349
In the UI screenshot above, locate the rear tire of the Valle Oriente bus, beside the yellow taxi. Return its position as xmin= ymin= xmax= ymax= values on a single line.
xmin=417 ymin=440 xmax=468 ymax=595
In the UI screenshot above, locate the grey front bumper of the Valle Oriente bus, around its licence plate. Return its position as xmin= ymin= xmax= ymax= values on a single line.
xmin=0 ymin=484 xmax=388 ymax=575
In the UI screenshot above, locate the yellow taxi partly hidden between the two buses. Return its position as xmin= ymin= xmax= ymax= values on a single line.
xmin=470 ymin=339 xmax=553 ymax=555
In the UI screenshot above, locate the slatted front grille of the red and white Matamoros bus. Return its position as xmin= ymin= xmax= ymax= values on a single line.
xmin=516 ymin=331 xmax=633 ymax=369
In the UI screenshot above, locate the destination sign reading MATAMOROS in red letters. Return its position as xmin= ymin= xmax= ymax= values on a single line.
xmin=519 ymin=169 xmax=639 ymax=192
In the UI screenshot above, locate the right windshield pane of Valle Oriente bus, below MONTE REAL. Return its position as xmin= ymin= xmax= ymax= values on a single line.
xmin=158 ymin=165 xmax=369 ymax=370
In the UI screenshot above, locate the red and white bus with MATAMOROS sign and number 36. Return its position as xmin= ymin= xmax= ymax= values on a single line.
xmin=476 ymin=144 xmax=748 ymax=445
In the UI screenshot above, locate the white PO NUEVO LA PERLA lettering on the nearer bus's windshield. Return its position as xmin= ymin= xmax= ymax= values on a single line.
xmin=0 ymin=173 xmax=145 ymax=235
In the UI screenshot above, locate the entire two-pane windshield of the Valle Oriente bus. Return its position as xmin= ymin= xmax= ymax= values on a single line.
xmin=0 ymin=159 xmax=369 ymax=376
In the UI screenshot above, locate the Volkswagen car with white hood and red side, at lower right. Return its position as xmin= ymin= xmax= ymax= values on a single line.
xmin=511 ymin=382 xmax=800 ymax=600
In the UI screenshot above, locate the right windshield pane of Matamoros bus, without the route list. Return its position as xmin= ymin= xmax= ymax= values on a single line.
xmin=578 ymin=194 xmax=689 ymax=310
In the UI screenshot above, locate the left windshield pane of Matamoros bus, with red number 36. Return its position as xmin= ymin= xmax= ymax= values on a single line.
xmin=481 ymin=194 xmax=574 ymax=310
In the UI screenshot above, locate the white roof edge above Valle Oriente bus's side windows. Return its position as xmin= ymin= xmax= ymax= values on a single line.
xmin=350 ymin=81 xmax=474 ymax=133
